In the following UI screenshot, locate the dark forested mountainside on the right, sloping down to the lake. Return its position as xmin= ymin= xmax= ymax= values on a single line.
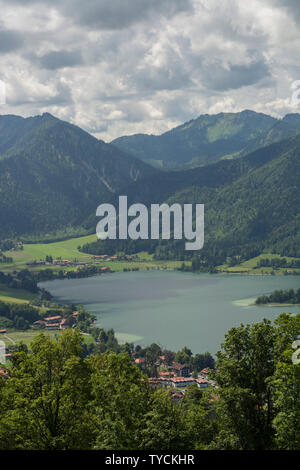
xmin=81 ymin=130 xmax=300 ymax=266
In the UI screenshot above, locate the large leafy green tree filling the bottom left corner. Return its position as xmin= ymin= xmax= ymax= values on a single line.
xmin=0 ymin=331 xmax=91 ymax=450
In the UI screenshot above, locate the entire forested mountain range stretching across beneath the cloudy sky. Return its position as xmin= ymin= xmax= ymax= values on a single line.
xmin=0 ymin=111 xmax=300 ymax=256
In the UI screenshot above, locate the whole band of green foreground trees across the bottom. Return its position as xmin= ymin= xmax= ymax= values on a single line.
xmin=0 ymin=314 xmax=300 ymax=451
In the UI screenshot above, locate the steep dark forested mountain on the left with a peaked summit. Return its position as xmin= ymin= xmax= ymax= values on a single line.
xmin=0 ymin=113 xmax=155 ymax=237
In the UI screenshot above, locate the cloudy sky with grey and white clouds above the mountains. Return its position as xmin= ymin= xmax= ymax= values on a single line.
xmin=0 ymin=0 xmax=300 ymax=142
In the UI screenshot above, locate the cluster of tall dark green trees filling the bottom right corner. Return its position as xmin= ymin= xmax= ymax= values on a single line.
xmin=211 ymin=314 xmax=300 ymax=450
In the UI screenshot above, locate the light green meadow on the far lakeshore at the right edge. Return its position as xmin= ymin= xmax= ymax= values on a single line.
xmin=218 ymin=253 xmax=300 ymax=275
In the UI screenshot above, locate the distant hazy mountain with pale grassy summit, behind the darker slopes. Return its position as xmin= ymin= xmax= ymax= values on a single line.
xmin=111 ymin=110 xmax=300 ymax=169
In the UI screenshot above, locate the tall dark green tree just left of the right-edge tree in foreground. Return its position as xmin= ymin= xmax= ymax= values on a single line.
xmin=216 ymin=320 xmax=276 ymax=450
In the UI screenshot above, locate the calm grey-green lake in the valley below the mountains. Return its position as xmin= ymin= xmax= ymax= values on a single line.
xmin=40 ymin=271 xmax=300 ymax=354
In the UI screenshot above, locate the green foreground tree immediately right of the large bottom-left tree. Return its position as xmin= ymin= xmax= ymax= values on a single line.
xmin=88 ymin=352 xmax=150 ymax=450
